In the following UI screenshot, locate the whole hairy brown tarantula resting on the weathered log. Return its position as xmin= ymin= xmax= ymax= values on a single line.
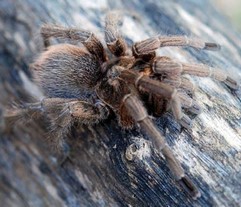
xmin=7 ymin=12 xmax=239 ymax=199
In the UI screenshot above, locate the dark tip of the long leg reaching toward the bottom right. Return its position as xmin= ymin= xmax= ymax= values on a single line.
xmin=178 ymin=175 xmax=201 ymax=200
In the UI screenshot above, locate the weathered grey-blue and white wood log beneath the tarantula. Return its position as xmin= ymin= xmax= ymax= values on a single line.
xmin=0 ymin=0 xmax=241 ymax=206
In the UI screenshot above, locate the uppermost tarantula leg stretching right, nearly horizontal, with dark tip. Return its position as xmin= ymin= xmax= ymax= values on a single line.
xmin=132 ymin=36 xmax=221 ymax=57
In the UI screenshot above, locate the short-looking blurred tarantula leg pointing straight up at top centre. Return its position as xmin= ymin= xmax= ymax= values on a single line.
xmin=105 ymin=12 xmax=127 ymax=57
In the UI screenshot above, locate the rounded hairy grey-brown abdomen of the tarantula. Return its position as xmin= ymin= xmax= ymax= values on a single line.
xmin=32 ymin=44 xmax=101 ymax=98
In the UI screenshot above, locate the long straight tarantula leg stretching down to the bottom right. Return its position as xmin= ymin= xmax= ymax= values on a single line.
xmin=123 ymin=94 xmax=200 ymax=199
